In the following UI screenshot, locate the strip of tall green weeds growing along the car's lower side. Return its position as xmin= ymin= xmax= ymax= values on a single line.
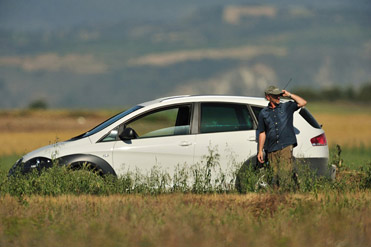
xmin=0 ymin=153 xmax=371 ymax=200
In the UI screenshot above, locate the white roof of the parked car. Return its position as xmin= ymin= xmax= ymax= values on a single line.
xmin=139 ymin=95 xmax=267 ymax=106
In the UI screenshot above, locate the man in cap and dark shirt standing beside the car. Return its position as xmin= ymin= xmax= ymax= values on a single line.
xmin=258 ymin=86 xmax=307 ymax=185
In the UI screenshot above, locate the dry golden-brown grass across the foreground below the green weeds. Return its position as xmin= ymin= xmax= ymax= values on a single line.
xmin=0 ymin=191 xmax=371 ymax=247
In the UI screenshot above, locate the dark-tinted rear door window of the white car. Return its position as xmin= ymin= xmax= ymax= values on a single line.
xmin=200 ymin=103 xmax=254 ymax=133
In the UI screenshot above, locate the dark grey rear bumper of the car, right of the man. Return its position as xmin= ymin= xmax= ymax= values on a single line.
xmin=295 ymin=158 xmax=336 ymax=179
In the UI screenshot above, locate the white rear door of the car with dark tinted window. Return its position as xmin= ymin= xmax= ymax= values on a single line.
xmin=195 ymin=103 xmax=257 ymax=172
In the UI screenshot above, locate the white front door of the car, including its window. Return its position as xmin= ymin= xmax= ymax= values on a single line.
xmin=113 ymin=104 xmax=195 ymax=174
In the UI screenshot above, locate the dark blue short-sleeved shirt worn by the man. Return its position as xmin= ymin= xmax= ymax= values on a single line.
xmin=258 ymin=101 xmax=299 ymax=153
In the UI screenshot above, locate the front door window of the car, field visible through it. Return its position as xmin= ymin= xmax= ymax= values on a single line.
xmin=126 ymin=105 xmax=191 ymax=138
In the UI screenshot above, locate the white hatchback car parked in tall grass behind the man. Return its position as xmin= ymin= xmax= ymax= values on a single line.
xmin=10 ymin=95 xmax=333 ymax=180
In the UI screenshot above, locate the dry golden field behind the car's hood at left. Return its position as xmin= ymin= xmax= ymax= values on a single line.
xmin=0 ymin=111 xmax=110 ymax=155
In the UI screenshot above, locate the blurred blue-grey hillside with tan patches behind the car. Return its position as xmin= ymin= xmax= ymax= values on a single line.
xmin=0 ymin=0 xmax=371 ymax=108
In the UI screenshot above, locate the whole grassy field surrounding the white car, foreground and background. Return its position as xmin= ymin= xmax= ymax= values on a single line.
xmin=0 ymin=104 xmax=371 ymax=246
